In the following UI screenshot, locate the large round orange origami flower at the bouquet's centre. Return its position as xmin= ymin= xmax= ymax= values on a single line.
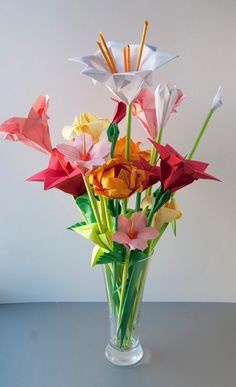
xmin=89 ymin=158 xmax=147 ymax=199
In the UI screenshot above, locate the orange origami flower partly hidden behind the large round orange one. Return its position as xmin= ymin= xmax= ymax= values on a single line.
xmin=114 ymin=136 xmax=150 ymax=161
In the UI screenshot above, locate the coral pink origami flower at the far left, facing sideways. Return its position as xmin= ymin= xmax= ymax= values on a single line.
xmin=0 ymin=96 xmax=52 ymax=154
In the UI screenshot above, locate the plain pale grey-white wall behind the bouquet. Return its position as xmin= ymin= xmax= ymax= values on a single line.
xmin=0 ymin=0 xmax=236 ymax=302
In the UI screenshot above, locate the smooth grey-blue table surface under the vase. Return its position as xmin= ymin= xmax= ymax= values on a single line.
xmin=0 ymin=303 xmax=236 ymax=387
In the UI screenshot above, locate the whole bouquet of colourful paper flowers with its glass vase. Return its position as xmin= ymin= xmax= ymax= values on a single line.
xmin=0 ymin=22 xmax=222 ymax=365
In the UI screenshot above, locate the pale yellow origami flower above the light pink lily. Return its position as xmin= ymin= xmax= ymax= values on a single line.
xmin=62 ymin=113 xmax=109 ymax=143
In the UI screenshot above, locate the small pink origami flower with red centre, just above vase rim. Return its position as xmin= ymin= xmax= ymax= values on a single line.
xmin=112 ymin=211 xmax=158 ymax=251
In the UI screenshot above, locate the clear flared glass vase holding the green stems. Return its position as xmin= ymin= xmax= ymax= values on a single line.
xmin=103 ymin=257 xmax=150 ymax=366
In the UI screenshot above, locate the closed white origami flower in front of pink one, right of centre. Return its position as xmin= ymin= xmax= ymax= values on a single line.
xmin=155 ymin=84 xmax=184 ymax=130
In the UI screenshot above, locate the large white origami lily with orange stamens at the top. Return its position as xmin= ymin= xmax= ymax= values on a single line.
xmin=70 ymin=21 xmax=177 ymax=104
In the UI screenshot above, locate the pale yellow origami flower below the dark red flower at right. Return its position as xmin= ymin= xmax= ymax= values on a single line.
xmin=141 ymin=196 xmax=182 ymax=230
